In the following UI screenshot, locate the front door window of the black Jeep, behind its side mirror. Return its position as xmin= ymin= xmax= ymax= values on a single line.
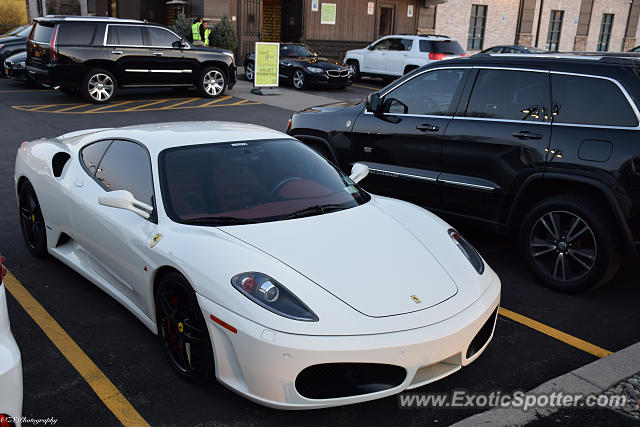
xmin=382 ymin=68 xmax=465 ymax=116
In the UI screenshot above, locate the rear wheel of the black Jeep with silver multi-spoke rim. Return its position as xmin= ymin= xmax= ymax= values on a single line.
xmin=519 ymin=195 xmax=621 ymax=293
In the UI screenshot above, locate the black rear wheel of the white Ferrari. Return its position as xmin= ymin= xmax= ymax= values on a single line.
xmin=18 ymin=181 xmax=48 ymax=258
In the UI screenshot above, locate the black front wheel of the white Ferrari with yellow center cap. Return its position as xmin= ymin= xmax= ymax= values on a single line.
xmin=155 ymin=272 xmax=215 ymax=383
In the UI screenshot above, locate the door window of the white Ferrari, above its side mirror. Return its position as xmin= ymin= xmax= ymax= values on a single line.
xmin=96 ymin=139 xmax=153 ymax=205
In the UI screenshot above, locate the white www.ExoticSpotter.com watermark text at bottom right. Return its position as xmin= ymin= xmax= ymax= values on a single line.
xmin=398 ymin=390 xmax=627 ymax=411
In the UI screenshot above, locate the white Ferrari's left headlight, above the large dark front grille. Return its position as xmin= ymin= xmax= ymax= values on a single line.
xmin=231 ymin=271 xmax=318 ymax=322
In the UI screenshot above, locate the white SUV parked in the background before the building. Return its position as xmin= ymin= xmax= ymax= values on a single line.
xmin=344 ymin=35 xmax=466 ymax=79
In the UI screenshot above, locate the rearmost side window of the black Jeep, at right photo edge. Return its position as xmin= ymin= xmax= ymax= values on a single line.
xmin=551 ymin=74 xmax=638 ymax=127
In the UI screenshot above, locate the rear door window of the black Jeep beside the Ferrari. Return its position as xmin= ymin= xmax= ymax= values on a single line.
xmin=466 ymin=70 xmax=549 ymax=121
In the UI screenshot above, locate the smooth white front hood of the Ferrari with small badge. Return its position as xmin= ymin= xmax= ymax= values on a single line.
xmin=222 ymin=202 xmax=458 ymax=317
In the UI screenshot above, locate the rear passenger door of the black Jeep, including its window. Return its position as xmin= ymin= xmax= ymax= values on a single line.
xmin=439 ymin=68 xmax=551 ymax=222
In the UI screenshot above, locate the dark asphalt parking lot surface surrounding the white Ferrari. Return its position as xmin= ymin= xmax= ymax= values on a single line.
xmin=0 ymin=79 xmax=640 ymax=426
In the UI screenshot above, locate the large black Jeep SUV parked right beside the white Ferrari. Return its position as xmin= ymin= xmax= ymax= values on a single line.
xmin=288 ymin=55 xmax=640 ymax=292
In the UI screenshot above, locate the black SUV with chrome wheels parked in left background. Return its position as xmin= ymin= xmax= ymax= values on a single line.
xmin=26 ymin=16 xmax=236 ymax=103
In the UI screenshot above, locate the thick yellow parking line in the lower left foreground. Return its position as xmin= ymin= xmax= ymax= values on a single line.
xmin=4 ymin=272 xmax=149 ymax=426
